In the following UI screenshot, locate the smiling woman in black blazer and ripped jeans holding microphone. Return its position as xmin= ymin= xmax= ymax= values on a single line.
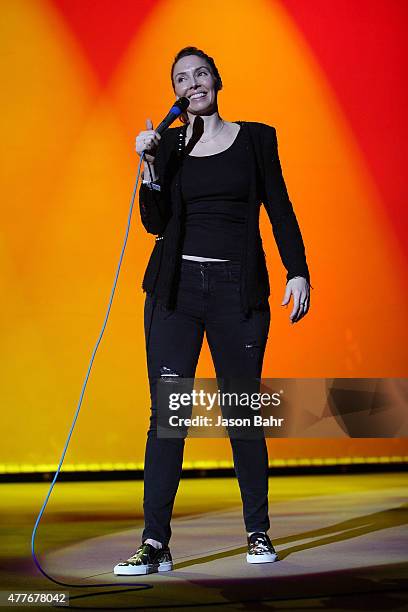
xmin=114 ymin=47 xmax=309 ymax=574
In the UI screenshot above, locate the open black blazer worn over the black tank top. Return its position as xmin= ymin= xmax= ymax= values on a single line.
xmin=139 ymin=121 xmax=310 ymax=314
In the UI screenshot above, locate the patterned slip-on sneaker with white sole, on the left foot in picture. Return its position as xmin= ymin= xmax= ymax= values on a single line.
xmin=113 ymin=543 xmax=173 ymax=576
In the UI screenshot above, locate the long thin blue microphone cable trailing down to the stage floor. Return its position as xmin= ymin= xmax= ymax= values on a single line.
xmin=31 ymin=153 xmax=153 ymax=590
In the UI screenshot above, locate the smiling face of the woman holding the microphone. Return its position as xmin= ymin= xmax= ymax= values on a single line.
xmin=173 ymin=55 xmax=217 ymax=115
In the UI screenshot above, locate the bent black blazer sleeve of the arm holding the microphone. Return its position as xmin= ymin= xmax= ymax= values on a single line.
xmin=139 ymin=132 xmax=171 ymax=234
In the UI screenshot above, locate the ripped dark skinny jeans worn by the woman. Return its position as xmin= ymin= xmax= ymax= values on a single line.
xmin=142 ymin=259 xmax=270 ymax=545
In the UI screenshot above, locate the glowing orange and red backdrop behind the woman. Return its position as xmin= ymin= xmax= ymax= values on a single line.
xmin=0 ymin=0 xmax=408 ymax=467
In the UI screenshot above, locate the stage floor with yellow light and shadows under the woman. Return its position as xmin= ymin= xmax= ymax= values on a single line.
xmin=0 ymin=473 xmax=408 ymax=610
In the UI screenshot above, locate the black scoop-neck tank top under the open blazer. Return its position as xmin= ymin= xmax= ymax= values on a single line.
xmin=181 ymin=126 xmax=250 ymax=260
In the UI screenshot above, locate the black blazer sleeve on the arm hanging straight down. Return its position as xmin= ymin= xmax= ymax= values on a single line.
xmin=262 ymin=124 xmax=310 ymax=285
